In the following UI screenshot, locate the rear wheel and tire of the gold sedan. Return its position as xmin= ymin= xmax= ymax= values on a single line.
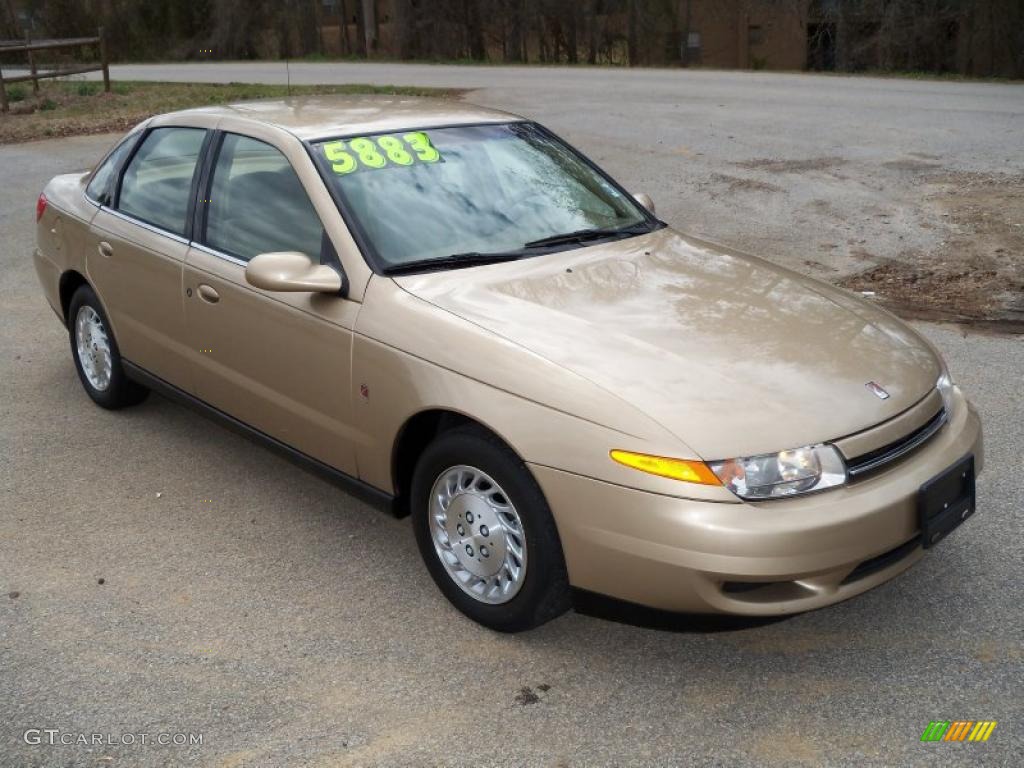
xmin=68 ymin=286 xmax=150 ymax=411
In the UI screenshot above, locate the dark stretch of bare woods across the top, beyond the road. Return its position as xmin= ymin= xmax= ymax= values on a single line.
xmin=18 ymin=0 xmax=1024 ymax=77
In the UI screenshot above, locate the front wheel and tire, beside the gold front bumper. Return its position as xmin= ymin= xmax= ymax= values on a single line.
xmin=411 ymin=427 xmax=571 ymax=632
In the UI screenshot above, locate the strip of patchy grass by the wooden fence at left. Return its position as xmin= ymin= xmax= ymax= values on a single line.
xmin=0 ymin=80 xmax=463 ymax=144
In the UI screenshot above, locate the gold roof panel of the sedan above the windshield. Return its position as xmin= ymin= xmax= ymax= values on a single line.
xmin=176 ymin=95 xmax=522 ymax=139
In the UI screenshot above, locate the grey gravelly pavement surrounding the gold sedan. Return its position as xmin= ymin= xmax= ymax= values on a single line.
xmin=0 ymin=65 xmax=1024 ymax=768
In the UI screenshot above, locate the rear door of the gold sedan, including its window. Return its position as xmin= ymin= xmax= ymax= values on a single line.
xmin=86 ymin=127 xmax=209 ymax=389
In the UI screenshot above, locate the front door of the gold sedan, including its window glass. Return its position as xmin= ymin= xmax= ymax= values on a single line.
xmin=184 ymin=133 xmax=359 ymax=476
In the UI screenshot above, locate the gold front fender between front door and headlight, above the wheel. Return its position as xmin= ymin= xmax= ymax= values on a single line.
xmin=352 ymin=279 xmax=736 ymax=502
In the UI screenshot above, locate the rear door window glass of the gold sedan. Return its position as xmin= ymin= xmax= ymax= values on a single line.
xmin=118 ymin=128 xmax=206 ymax=236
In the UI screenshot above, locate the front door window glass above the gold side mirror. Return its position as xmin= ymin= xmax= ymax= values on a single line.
xmin=206 ymin=133 xmax=325 ymax=261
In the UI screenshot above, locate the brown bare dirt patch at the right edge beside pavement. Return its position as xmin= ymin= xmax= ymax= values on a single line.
xmin=841 ymin=173 xmax=1024 ymax=333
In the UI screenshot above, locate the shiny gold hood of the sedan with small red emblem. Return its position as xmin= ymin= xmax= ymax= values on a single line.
xmin=396 ymin=229 xmax=940 ymax=460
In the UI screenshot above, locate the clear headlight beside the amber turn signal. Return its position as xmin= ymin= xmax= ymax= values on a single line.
xmin=708 ymin=444 xmax=846 ymax=499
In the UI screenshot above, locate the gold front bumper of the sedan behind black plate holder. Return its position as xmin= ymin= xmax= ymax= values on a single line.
xmin=530 ymin=390 xmax=984 ymax=615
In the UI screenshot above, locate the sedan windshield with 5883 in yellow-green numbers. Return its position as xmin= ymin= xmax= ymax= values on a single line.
xmin=313 ymin=123 xmax=659 ymax=271
